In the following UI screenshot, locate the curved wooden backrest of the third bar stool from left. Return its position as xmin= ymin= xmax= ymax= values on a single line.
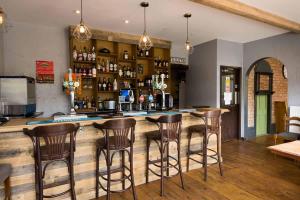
xmin=157 ymin=114 xmax=182 ymax=141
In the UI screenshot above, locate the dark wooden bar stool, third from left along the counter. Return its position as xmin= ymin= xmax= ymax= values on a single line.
xmin=146 ymin=114 xmax=184 ymax=196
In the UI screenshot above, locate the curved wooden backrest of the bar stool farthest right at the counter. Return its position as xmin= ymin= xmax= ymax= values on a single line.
xmin=204 ymin=110 xmax=221 ymax=135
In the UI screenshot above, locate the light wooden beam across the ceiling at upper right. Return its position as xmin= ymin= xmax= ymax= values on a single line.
xmin=190 ymin=0 xmax=300 ymax=33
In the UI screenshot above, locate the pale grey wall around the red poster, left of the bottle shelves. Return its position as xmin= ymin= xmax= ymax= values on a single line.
xmin=3 ymin=22 xmax=69 ymax=116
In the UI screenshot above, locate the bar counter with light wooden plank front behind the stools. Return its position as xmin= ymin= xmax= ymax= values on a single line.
xmin=0 ymin=110 xmax=226 ymax=200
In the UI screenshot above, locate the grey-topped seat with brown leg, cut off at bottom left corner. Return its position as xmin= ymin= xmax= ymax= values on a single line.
xmin=0 ymin=164 xmax=12 ymax=200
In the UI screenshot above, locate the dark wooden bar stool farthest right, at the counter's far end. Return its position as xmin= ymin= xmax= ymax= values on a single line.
xmin=187 ymin=110 xmax=223 ymax=181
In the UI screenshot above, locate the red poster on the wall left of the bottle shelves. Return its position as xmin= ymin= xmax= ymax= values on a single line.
xmin=36 ymin=60 xmax=54 ymax=84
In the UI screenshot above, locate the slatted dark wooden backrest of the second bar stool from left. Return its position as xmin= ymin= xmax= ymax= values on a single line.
xmin=94 ymin=118 xmax=136 ymax=149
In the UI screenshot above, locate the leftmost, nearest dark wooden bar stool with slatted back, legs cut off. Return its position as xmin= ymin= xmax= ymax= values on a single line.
xmin=23 ymin=124 xmax=79 ymax=200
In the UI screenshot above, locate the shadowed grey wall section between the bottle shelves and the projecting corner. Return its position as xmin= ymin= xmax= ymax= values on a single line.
xmin=186 ymin=40 xmax=217 ymax=107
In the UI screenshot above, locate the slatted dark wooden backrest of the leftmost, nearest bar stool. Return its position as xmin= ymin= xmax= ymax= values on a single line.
xmin=23 ymin=123 xmax=79 ymax=160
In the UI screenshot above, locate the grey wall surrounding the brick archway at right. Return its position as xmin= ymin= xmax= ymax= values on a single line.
xmin=243 ymin=33 xmax=300 ymax=137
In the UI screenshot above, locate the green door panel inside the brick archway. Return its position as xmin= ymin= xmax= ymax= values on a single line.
xmin=256 ymin=95 xmax=268 ymax=136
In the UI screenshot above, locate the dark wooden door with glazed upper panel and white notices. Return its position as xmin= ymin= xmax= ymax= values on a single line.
xmin=220 ymin=66 xmax=241 ymax=142
